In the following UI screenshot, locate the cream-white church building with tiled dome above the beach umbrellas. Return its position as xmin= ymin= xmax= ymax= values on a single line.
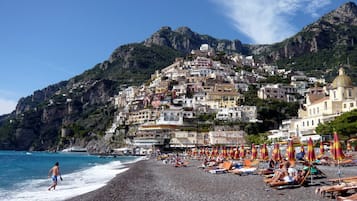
xmin=268 ymin=68 xmax=357 ymax=142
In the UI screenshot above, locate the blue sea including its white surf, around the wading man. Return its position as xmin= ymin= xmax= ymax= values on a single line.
xmin=0 ymin=151 xmax=142 ymax=201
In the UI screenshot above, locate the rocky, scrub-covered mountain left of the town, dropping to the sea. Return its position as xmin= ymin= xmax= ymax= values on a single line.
xmin=0 ymin=27 xmax=244 ymax=150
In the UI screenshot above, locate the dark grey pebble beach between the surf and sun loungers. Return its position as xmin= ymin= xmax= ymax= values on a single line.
xmin=69 ymin=159 xmax=357 ymax=201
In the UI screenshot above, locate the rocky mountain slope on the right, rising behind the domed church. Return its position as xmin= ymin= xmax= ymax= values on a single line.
xmin=251 ymin=2 xmax=357 ymax=83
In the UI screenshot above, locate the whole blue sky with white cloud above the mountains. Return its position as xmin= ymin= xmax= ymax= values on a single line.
xmin=0 ymin=0 xmax=357 ymax=115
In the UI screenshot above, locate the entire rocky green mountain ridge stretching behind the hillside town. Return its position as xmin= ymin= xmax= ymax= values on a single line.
xmin=0 ymin=2 xmax=357 ymax=152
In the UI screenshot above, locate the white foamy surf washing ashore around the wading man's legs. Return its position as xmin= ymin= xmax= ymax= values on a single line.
xmin=0 ymin=159 xmax=134 ymax=201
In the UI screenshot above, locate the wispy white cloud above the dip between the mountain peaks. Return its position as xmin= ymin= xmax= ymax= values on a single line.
xmin=213 ymin=0 xmax=331 ymax=44
